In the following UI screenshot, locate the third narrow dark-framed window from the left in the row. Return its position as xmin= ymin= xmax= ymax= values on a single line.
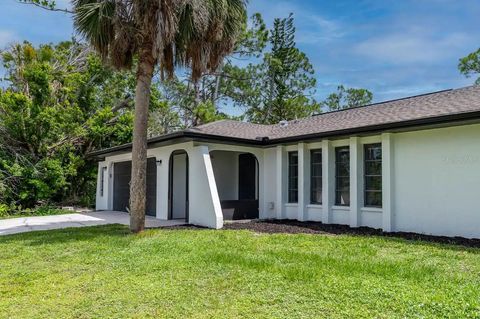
xmin=335 ymin=146 xmax=350 ymax=206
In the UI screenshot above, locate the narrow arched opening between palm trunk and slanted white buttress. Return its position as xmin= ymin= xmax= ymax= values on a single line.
xmin=168 ymin=150 xmax=189 ymax=221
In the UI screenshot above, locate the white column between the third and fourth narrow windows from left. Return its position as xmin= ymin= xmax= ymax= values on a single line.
xmin=350 ymin=136 xmax=362 ymax=227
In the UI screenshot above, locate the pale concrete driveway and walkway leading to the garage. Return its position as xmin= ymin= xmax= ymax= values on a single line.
xmin=0 ymin=211 xmax=185 ymax=236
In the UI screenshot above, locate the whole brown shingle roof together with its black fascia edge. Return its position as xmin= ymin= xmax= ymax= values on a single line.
xmin=89 ymin=85 xmax=480 ymax=158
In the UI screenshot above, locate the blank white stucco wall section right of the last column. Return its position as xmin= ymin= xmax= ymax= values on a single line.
xmin=392 ymin=125 xmax=480 ymax=238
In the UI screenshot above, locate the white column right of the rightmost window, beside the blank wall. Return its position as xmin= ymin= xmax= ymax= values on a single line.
xmin=382 ymin=133 xmax=394 ymax=232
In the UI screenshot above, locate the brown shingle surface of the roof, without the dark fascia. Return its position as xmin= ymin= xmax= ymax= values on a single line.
xmin=187 ymin=86 xmax=480 ymax=140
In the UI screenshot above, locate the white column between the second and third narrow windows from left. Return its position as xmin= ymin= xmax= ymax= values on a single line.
xmin=322 ymin=140 xmax=335 ymax=224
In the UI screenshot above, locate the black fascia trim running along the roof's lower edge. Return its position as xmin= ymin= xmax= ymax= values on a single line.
xmin=87 ymin=111 xmax=480 ymax=159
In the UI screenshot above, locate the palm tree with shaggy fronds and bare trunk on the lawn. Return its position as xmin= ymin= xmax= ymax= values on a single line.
xmin=72 ymin=0 xmax=247 ymax=232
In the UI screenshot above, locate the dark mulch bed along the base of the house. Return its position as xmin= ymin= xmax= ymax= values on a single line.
xmin=223 ymin=220 xmax=480 ymax=248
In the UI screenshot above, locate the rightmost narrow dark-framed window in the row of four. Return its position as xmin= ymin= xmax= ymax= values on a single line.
xmin=364 ymin=143 xmax=382 ymax=207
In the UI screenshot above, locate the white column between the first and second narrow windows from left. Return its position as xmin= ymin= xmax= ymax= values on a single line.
xmin=297 ymin=143 xmax=310 ymax=221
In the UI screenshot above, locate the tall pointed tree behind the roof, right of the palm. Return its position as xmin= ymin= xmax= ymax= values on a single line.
xmin=230 ymin=14 xmax=319 ymax=124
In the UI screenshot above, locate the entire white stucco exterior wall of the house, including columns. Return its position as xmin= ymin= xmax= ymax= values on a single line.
xmin=97 ymin=124 xmax=480 ymax=238
